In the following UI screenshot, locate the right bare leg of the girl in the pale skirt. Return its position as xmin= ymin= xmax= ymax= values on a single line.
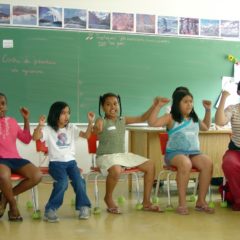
xmin=138 ymin=160 xmax=155 ymax=207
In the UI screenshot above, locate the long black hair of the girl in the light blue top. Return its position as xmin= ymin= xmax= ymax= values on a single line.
xmin=170 ymin=91 xmax=198 ymax=123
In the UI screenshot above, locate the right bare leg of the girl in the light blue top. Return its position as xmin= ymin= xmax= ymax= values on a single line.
xmin=191 ymin=154 xmax=213 ymax=206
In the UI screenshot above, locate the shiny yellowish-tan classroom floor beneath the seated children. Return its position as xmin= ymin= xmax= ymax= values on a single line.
xmin=0 ymin=181 xmax=240 ymax=240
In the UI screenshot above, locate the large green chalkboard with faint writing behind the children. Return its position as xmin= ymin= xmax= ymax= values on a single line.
xmin=0 ymin=27 xmax=240 ymax=122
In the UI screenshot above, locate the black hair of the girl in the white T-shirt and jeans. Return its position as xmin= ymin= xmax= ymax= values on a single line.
xmin=47 ymin=102 xmax=70 ymax=131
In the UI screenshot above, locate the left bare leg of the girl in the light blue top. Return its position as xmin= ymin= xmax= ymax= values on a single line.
xmin=171 ymin=155 xmax=192 ymax=207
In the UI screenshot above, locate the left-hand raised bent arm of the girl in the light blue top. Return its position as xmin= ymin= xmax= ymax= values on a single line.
xmin=148 ymin=97 xmax=172 ymax=128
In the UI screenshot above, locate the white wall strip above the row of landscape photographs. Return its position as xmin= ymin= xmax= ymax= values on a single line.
xmin=0 ymin=0 xmax=240 ymax=20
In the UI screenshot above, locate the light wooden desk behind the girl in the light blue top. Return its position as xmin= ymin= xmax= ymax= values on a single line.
xmin=127 ymin=126 xmax=231 ymax=177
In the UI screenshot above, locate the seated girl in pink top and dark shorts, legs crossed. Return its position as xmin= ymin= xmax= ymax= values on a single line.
xmin=0 ymin=93 xmax=41 ymax=221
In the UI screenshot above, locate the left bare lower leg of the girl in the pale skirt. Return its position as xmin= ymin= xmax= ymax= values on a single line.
xmin=104 ymin=165 xmax=122 ymax=209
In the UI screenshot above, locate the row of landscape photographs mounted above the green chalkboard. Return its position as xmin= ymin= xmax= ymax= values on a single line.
xmin=0 ymin=4 xmax=240 ymax=38
